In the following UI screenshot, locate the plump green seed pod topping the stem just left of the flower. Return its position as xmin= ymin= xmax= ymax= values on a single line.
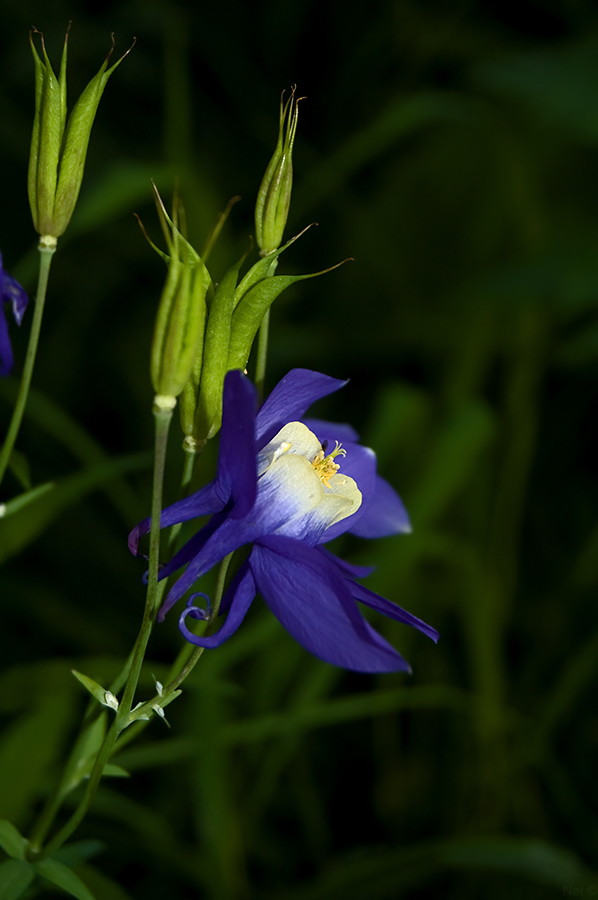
xmin=151 ymin=191 xmax=212 ymax=405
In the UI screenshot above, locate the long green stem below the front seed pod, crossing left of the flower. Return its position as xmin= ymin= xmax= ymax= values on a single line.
xmin=36 ymin=398 xmax=174 ymax=860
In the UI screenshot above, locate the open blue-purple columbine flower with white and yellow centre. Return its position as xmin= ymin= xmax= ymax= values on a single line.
xmin=129 ymin=369 xmax=438 ymax=672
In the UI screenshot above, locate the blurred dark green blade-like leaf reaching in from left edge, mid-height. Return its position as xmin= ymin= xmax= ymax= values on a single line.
xmin=0 ymin=453 xmax=149 ymax=563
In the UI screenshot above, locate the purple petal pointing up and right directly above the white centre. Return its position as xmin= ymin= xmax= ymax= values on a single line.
xmin=256 ymin=369 xmax=347 ymax=447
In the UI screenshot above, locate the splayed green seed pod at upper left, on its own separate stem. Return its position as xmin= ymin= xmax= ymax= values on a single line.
xmin=28 ymin=29 xmax=132 ymax=244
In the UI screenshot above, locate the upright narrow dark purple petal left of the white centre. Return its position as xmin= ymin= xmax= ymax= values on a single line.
xmin=217 ymin=369 xmax=257 ymax=518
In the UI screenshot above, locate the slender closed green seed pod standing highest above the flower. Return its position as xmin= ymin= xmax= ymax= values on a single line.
xmin=255 ymin=87 xmax=303 ymax=256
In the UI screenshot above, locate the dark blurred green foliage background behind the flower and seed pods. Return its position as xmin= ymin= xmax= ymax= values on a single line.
xmin=0 ymin=0 xmax=598 ymax=900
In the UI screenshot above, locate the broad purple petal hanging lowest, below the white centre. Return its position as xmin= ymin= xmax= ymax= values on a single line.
xmin=249 ymin=537 xmax=409 ymax=672
